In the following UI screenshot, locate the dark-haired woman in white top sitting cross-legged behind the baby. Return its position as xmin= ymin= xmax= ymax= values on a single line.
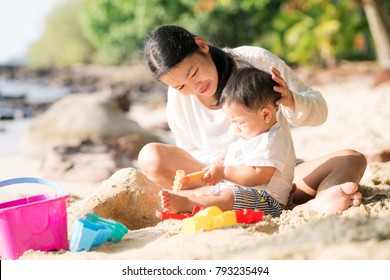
xmin=138 ymin=25 xmax=367 ymax=212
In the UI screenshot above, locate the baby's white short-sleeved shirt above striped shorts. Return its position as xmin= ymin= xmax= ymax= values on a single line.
xmin=224 ymin=110 xmax=295 ymax=205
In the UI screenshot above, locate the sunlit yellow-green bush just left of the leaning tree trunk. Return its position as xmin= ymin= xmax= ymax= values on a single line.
xmin=265 ymin=0 xmax=369 ymax=66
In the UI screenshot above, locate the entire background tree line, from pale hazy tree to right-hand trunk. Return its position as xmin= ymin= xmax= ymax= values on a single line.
xmin=30 ymin=0 xmax=390 ymax=68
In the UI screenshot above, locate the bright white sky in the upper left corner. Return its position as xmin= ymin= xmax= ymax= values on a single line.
xmin=0 ymin=0 xmax=66 ymax=64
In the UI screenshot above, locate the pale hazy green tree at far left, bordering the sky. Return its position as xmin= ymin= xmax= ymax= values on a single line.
xmin=29 ymin=1 xmax=94 ymax=68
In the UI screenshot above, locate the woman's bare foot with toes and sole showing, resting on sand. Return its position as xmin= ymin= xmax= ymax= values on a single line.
xmin=293 ymin=182 xmax=362 ymax=213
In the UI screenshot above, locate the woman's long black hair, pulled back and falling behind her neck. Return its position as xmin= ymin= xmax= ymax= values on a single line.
xmin=144 ymin=25 xmax=236 ymax=100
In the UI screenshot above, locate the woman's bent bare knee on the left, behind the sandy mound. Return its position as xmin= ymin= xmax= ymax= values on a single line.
xmin=138 ymin=143 xmax=204 ymax=189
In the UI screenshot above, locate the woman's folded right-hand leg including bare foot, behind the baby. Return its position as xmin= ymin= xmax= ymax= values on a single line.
xmin=292 ymin=150 xmax=367 ymax=212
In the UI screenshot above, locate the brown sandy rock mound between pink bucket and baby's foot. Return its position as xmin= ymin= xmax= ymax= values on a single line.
xmin=68 ymin=168 xmax=161 ymax=230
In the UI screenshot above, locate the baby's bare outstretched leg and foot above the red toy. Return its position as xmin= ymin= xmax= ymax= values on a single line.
xmin=159 ymin=189 xmax=234 ymax=213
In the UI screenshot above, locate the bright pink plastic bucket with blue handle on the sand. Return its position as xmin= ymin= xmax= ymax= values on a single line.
xmin=0 ymin=177 xmax=70 ymax=259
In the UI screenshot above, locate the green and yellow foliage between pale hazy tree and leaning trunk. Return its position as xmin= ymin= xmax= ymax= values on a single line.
xmin=80 ymin=0 xmax=368 ymax=65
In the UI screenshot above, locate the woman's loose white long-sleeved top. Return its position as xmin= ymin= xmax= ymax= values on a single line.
xmin=167 ymin=46 xmax=328 ymax=164
